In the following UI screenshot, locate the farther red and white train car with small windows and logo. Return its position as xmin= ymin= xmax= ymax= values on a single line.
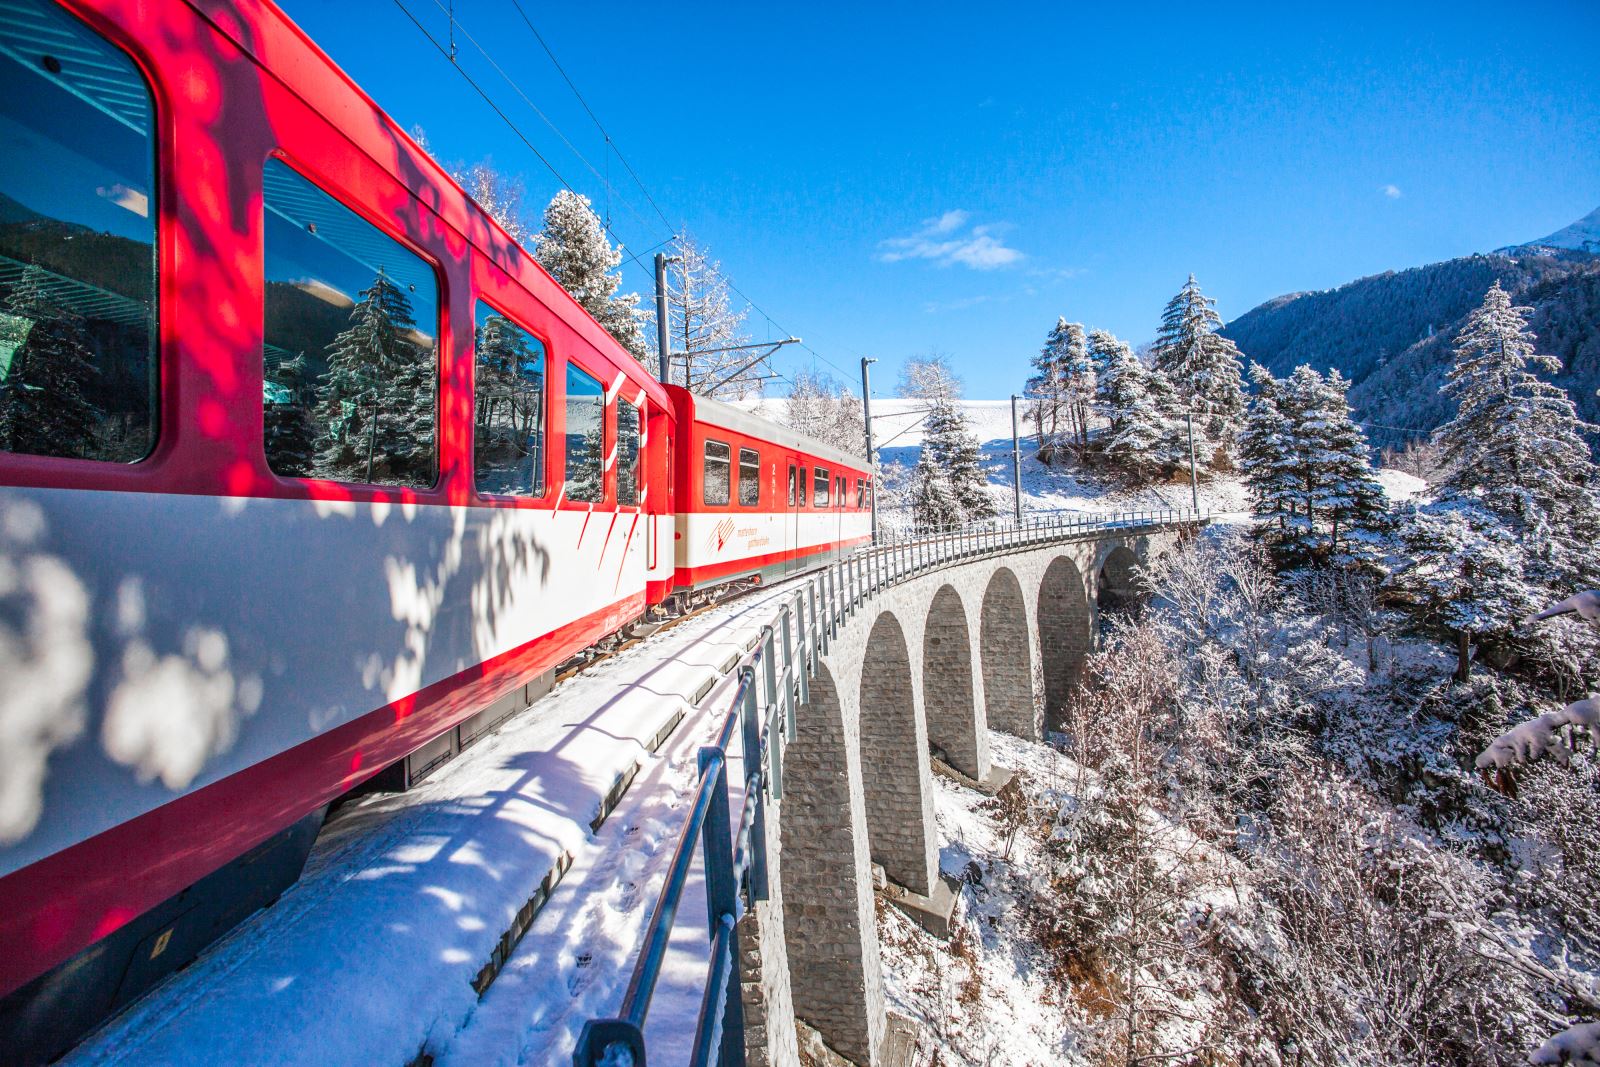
xmin=667 ymin=386 xmax=874 ymax=590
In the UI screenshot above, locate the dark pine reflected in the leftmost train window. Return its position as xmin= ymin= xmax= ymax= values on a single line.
xmin=0 ymin=264 xmax=102 ymax=458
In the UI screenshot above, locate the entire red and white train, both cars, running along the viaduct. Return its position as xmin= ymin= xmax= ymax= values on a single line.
xmin=0 ymin=0 xmax=872 ymax=1061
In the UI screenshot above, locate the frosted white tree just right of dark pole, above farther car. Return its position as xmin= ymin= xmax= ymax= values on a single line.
xmin=667 ymin=235 xmax=766 ymax=400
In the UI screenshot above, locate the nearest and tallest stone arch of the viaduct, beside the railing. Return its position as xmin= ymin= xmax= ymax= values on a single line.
xmin=779 ymin=664 xmax=885 ymax=1064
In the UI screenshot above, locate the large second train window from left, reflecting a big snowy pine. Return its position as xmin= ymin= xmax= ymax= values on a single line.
xmin=261 ymin=160 xmax=438 ymax=488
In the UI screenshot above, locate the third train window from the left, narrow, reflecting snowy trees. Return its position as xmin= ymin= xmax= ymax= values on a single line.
xmin=472 ymin=301 xmax=546 ymax=496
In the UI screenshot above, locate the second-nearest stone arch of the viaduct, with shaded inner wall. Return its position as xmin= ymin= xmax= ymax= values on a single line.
xmin=861 ymin=611 xmax=939 ymax=894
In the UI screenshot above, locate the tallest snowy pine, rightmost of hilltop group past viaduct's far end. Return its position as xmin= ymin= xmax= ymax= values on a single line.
xmin=1154 ymin=274 xmax=1245 ymax=464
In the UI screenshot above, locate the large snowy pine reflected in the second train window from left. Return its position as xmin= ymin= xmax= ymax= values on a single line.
xmin=300 ymin=269 xmax=435 ymax=486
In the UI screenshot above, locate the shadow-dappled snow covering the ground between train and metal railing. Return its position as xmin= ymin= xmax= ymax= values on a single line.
xmin=66 ymin=587 xmax=784 ymax=1065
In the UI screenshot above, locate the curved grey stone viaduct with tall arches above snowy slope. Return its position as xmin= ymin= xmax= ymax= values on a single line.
xmin=739 ymin=528 xmax=1179 ymax=1067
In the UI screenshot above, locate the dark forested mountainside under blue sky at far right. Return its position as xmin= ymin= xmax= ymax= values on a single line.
xmin=1222 ymin=250 xmax=1600 ymax=445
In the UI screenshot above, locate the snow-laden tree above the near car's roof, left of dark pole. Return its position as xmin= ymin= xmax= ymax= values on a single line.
xmin=533 ymin=189 xmax=650 ymax=363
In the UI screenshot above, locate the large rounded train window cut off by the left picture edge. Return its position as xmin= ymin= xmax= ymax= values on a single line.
xmin=0 ymin=0 xmax=158 ymax=462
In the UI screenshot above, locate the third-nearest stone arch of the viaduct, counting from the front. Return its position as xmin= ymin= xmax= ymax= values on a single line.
xmin=922 ymin=585 xmax=989 ymax=781
